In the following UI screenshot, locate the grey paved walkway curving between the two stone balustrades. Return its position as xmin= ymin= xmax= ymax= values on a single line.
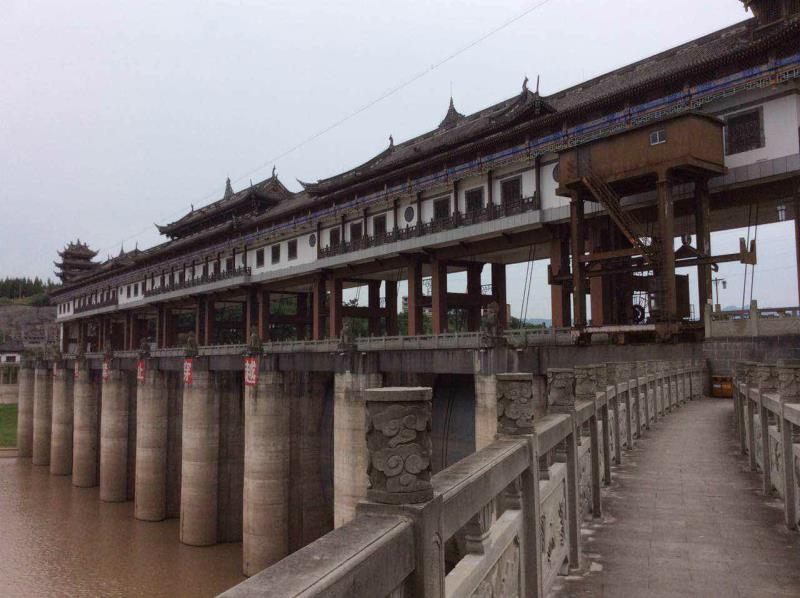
xmin=552 ymin=399 xmax=800 ymax=598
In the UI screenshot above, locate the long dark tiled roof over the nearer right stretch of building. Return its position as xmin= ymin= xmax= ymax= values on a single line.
xmin=296 ymin=15 xmax=798 ymax=195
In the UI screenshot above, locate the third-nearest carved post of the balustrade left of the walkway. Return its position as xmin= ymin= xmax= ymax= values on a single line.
xmin=547 ymin=368 xmax=581 ymax=569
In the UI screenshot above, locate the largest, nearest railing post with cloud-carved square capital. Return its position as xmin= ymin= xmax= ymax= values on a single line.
xmin=357 ymin=387 xmax=445 ymax=598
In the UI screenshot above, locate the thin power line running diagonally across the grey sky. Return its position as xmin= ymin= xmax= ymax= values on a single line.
xmin=98 ymin=0 xmax=553 ymax=253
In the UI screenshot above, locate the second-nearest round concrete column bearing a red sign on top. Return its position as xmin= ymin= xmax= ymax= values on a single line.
xmin=181 ymin=366 xmax=219 ymax=546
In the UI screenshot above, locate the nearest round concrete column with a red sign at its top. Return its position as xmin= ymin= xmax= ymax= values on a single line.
xmin=242 ymin=364 xmax=292 ymax=576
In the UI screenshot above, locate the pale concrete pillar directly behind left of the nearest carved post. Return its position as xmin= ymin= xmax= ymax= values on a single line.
xmin=333 ymin=353 xmax=382 ymax=527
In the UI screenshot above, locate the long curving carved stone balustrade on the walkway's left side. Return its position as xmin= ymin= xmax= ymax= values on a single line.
xmin=224 ymin=362 xmax=700 ymax=598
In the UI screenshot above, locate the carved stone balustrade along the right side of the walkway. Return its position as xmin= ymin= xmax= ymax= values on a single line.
xmin=733 ymin=361 xmax=800 ymax=529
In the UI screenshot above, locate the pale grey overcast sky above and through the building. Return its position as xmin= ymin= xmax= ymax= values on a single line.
xmin=0 ymin=0 xmax=797 ymax=317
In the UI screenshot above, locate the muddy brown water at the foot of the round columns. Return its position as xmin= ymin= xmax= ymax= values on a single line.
xmin=0 ymin=459 xmax=244 ymax=597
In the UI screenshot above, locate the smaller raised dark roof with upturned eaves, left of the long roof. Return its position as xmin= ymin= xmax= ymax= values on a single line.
xmin=156 ymin=169 xmax=295 ymax=239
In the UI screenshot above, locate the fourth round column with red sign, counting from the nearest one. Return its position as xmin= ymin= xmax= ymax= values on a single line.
xmin=100 ymin=366 xmax=128 ymax=502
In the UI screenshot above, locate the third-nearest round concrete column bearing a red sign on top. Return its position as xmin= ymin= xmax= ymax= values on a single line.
xmin=134 ymin=362 xmax=168 ymax=521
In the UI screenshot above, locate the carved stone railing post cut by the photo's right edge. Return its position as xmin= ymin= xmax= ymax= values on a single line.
xmin=777 ymin=363 xmax=800 ymax=529
